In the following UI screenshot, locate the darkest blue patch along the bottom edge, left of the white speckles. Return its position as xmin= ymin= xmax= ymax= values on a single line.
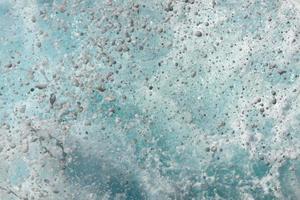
xmin=65 ymin=151 xmax=146 ymax=200
